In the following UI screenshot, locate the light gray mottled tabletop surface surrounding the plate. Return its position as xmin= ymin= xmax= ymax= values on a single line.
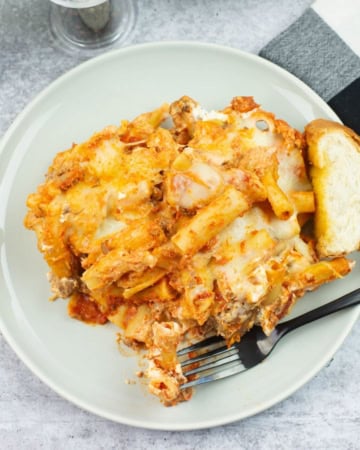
xmin=0 ymin=0 xmax=360 ymax=449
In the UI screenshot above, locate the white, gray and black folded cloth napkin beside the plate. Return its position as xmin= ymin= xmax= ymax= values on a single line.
xmin=260 ymin=0 xmax=360 ymax=133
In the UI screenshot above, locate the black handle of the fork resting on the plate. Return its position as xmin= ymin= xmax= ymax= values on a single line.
xmin=276 ymin=288 xmax=360 ymax=335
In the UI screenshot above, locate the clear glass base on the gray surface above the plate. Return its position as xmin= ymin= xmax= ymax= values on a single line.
xmin=50 ymin=0 xmax=136 ymax=50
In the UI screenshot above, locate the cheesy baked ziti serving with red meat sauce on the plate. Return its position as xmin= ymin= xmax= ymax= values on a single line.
xmin=25 ymin=96 xmax=353 ymax=405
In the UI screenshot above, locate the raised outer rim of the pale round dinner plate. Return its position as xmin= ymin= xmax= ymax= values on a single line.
xmin=0 ymin=40 xmax=360 ymax=431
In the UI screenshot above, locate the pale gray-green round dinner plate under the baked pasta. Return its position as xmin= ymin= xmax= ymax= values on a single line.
xmin=0 ymin=42 xmax=360 ymax=430
